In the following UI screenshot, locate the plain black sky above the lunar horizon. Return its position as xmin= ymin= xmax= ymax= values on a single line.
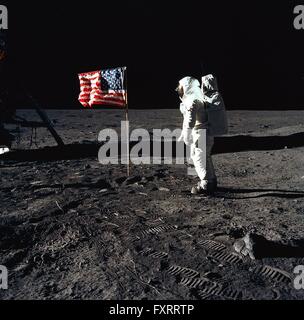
xmin=8 ymin=0 xmax=304 ymax=109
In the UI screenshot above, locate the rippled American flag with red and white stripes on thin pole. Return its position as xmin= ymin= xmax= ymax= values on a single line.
xmin=78 ymin=68 xmax=126 ymax=108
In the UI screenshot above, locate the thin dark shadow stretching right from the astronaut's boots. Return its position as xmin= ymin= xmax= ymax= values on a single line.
xmin=214 ymin=187 xmax=304 ymax=200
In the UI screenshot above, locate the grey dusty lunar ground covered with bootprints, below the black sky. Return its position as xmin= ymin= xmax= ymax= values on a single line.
xmin=0 ymin=109 xmax=304 ymax=300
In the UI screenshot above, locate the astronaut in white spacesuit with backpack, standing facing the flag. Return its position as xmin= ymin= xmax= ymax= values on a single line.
xmin=177 ymin=75 xmax=227 ymax=194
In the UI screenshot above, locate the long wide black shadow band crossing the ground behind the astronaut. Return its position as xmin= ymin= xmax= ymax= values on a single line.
xmin=0 ymin=132 xmax=304 ymax=161
